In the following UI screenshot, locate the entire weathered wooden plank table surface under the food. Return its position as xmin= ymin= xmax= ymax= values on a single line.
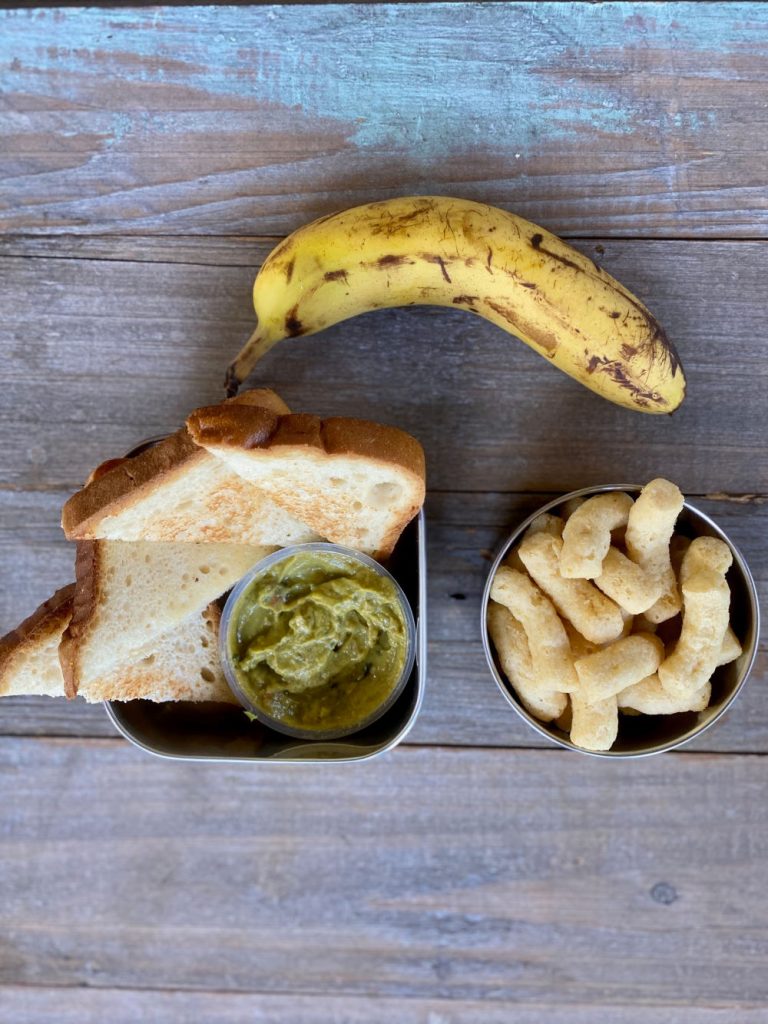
xmin=0 ymin=2 xmax=768 ymax=1024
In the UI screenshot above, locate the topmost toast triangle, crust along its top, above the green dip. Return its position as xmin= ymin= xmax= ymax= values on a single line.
xmin=186 ymin=404 xmax=425 ymax=558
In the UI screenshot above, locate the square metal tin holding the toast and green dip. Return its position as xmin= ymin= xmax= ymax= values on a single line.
xmin=104 ymin=509 xmax=427 ymax=764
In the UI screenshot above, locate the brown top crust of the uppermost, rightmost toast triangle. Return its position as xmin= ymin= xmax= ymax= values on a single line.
xmin=186 ymin=406 xmax=426 ymax=480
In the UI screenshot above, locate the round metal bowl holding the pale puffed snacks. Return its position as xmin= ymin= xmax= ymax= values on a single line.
xmin=480 ymin=483 xmax=760 ymax=758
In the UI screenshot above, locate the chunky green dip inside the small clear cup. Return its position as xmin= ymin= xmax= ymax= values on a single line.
xmin=229 ymin=550 xmax=408 ymax=732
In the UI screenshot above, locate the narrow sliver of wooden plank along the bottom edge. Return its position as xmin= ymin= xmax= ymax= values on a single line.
xmin=0 ymin=986 xmax=765 ymax=1024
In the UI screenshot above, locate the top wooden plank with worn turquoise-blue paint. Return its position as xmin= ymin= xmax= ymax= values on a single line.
xmin=0 ymin=2 xmax=768 ymax=237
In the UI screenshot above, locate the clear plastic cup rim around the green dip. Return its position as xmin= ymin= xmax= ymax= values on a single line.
xmin=219 ymin=542 xmax=417 ymax=740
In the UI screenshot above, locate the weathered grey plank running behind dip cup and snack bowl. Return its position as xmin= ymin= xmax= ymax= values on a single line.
xmin=0 ymin=492 xmax=768 ymax=753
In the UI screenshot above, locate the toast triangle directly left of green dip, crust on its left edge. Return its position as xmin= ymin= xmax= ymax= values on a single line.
xmin=58 ymin=541 xmax=272 ymax=697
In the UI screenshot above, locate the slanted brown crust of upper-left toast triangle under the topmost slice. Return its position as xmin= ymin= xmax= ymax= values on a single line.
xmin=61 ymin=388 xmax=289 ymax=541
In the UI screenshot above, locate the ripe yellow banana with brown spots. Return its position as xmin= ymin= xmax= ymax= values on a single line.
xmin=226 ymin=196 xmax=685 ymax=413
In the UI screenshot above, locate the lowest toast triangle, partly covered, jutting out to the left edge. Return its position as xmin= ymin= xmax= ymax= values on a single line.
xmin=0 ymin=584 xmax=237 ymax=703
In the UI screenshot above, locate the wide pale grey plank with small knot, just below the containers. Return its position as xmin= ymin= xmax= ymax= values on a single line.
xmin=0 ymin=739 xmax=768 ymax=1013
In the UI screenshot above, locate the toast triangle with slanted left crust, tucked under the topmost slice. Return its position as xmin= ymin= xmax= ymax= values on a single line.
xmin=61 ymin=388 xmax=317 ymax=547
